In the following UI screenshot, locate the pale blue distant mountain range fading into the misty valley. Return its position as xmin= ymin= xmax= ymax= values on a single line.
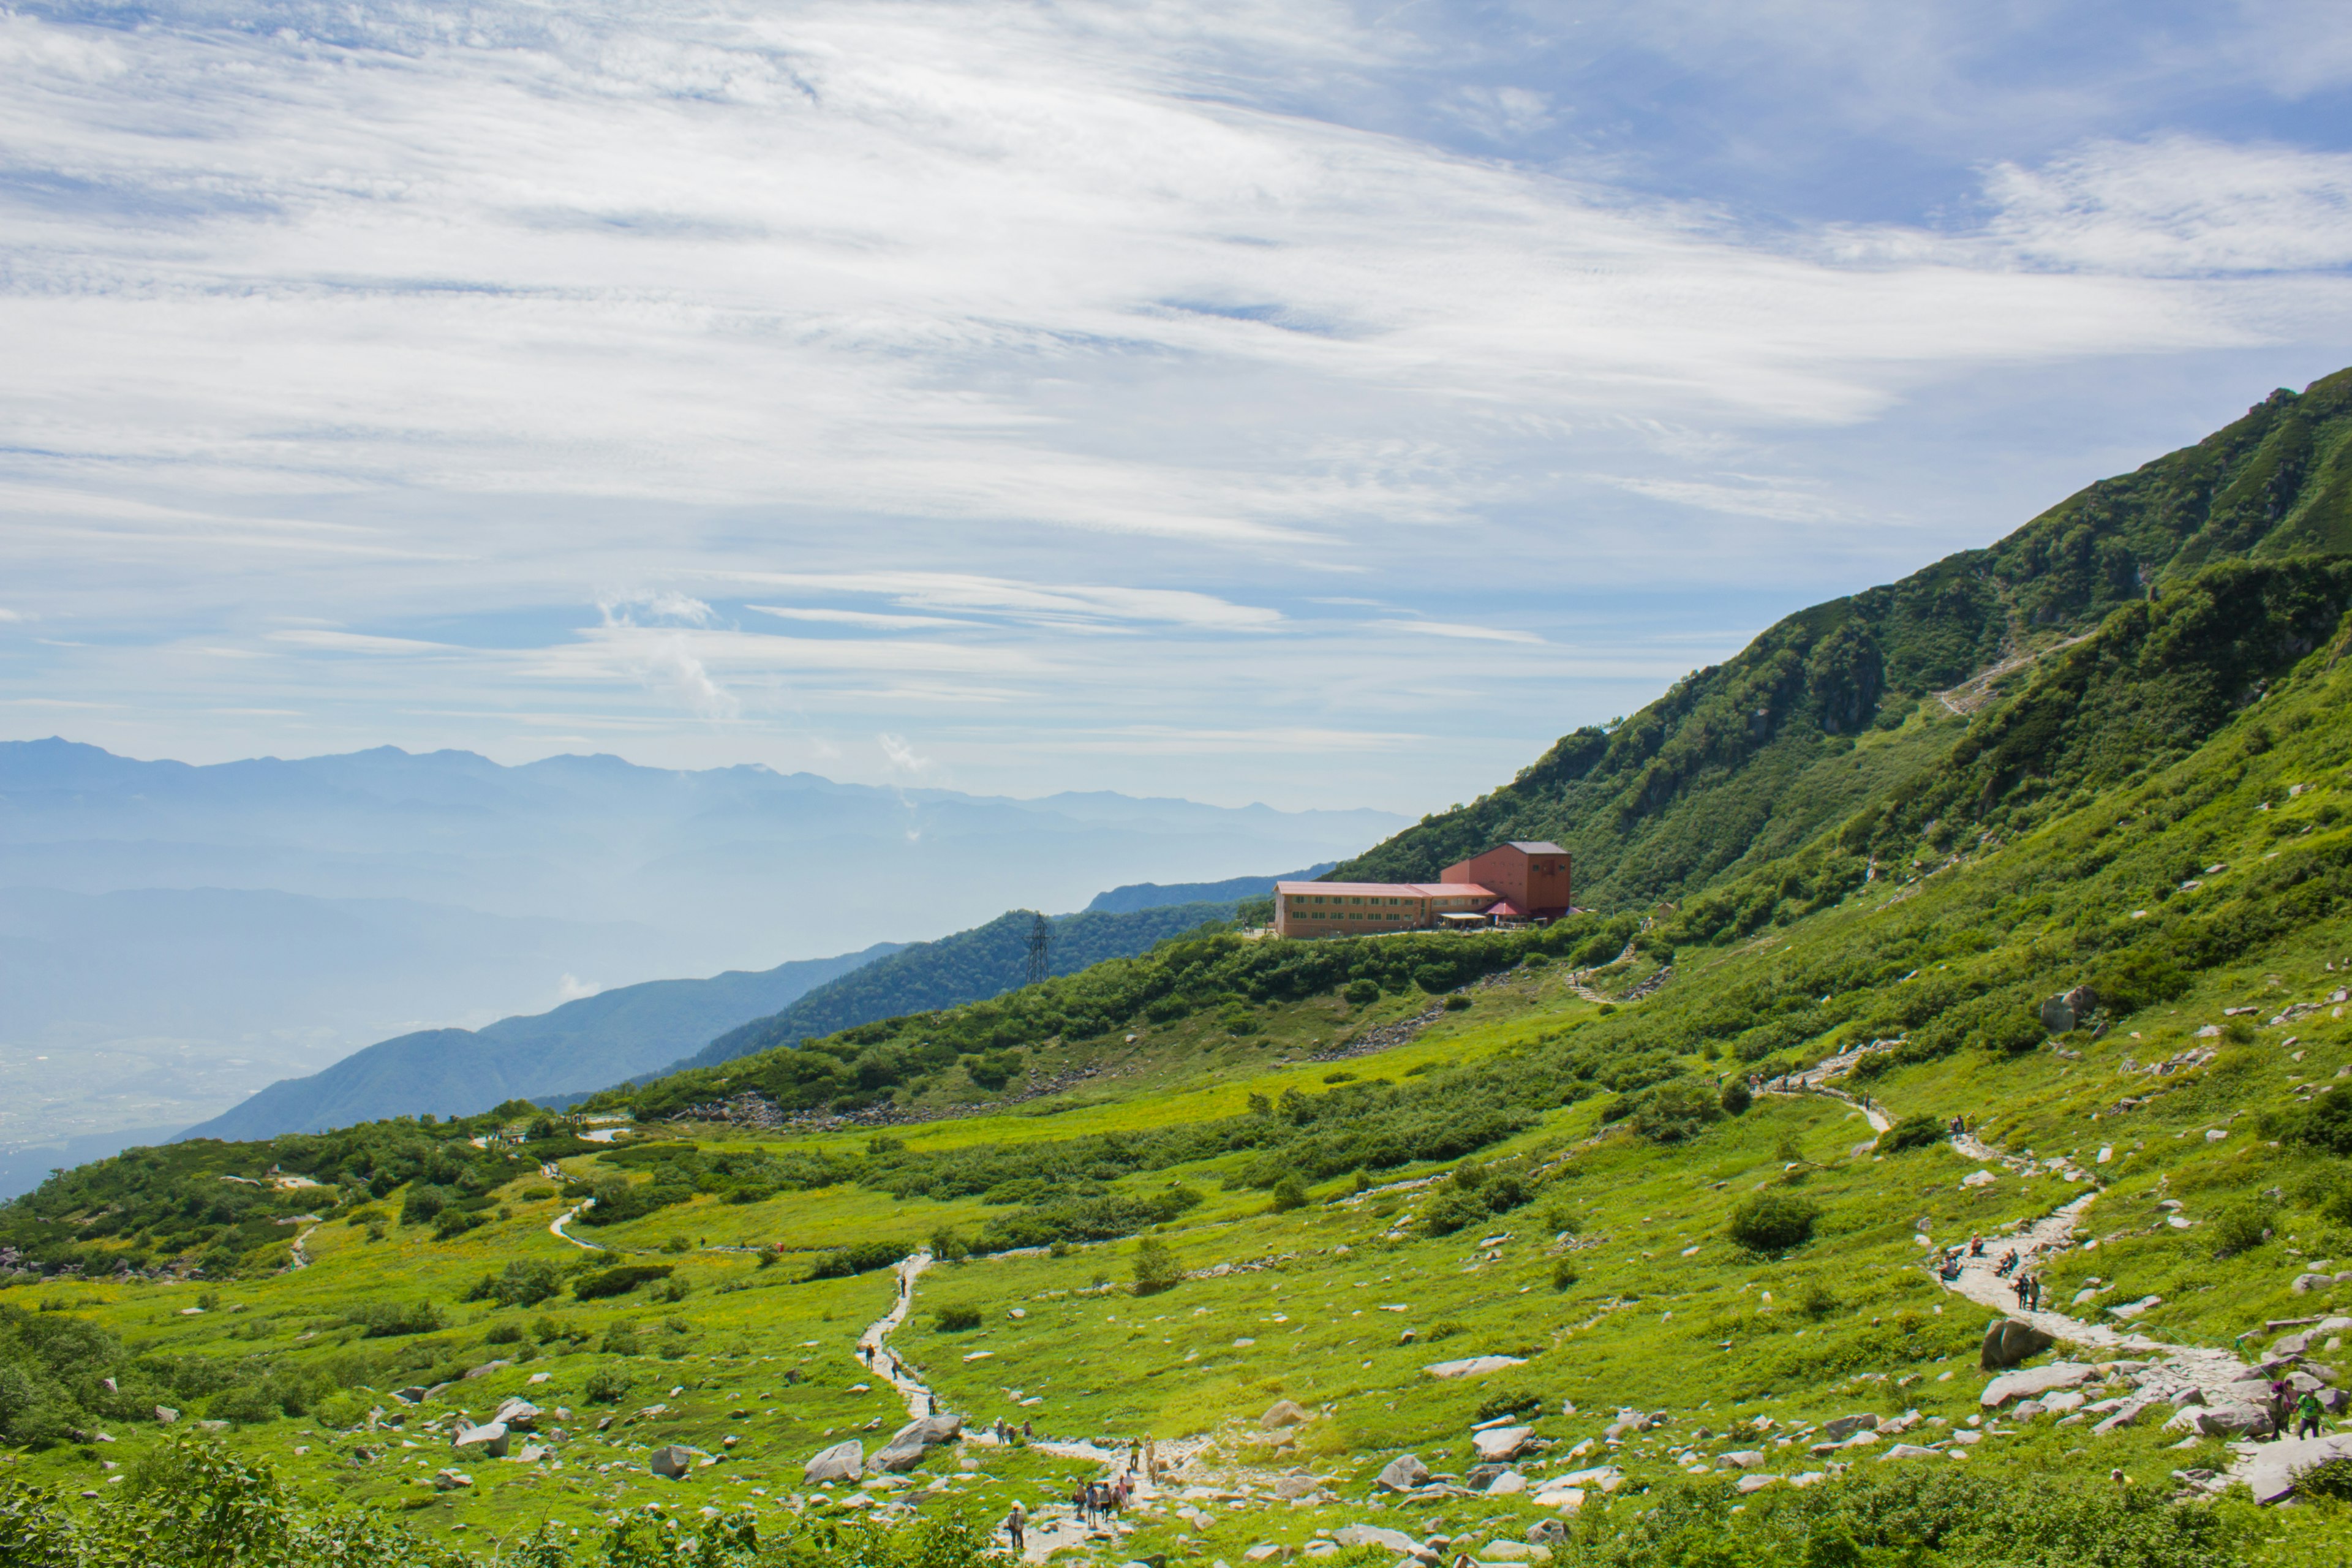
xmin=0 ymin=738 xmax=1402 ymax=1161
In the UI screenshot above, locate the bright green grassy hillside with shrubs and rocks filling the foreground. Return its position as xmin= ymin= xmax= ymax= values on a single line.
xmin=13 ymin=545 xmax=2352 ymax=1568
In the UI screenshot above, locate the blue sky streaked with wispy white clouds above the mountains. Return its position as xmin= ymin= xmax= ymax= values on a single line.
xmin=0 ymin=0 xmax=2352 ymax=811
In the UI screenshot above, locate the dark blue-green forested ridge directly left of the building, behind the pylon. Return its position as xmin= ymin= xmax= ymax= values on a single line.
xmin=670 ymin=900 xmax=1235 ymax=1072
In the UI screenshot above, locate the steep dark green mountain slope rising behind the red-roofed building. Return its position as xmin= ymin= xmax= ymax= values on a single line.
xmin=1331 ymin=371 xmax=2352 ymax=910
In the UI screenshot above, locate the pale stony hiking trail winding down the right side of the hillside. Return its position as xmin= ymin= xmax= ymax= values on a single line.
xmin=1759 ymin=1072 xmax=2352 ymax=1502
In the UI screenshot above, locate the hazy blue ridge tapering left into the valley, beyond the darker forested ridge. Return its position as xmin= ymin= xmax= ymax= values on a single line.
xmin=181 ymin=943 xmax=901 ymax=1140
